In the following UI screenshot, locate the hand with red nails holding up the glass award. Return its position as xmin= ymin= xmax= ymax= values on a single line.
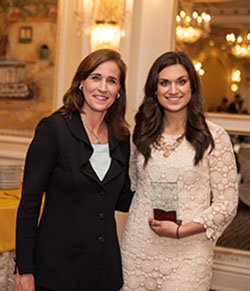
xmin=149 ymin=218 xmax=178 ymax=238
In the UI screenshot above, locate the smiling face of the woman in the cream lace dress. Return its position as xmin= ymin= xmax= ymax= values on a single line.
xmin=157 ymin=64 xmax=192 ymax=116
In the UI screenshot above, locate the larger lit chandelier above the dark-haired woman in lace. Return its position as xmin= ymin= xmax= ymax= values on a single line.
xmin=176 ymin=10 xmax=211 ymax=43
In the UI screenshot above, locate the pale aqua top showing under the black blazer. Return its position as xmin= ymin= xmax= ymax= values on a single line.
xmin=89 ymin=143 xmax=111 ymax=181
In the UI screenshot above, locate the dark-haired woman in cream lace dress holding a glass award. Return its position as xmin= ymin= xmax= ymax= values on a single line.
xmin=122 ymin=52 xmax=238 ymax=291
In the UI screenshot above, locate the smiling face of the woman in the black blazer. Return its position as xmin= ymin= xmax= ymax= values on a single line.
xmin=81 ymin=61 xmax=120 ymax=113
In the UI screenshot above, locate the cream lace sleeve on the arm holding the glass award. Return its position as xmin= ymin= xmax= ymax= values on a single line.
xmin=194 ymin=128 xmax=238 ymax=241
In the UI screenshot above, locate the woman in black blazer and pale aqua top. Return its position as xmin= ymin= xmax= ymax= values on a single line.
xmin=15 ymin=49 xmax=133 ymax=291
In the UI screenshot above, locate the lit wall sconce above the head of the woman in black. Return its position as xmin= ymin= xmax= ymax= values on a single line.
xmin=74 ymin=0 xmax=133 ymax=51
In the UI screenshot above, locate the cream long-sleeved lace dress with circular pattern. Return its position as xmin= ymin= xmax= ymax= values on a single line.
xmin=121 ymin=121 xmax=238 ymax=291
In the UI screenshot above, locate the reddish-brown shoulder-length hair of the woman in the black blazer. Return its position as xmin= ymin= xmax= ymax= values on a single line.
xmin=56 ymin=49 xmax=129 ymax=143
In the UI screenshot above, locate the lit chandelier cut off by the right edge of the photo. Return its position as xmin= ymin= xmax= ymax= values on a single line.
xmin=226 ymin=33 xmax=250 ymax=58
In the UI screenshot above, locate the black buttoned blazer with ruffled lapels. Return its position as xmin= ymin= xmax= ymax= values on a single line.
xmin=16 ymin=113 xmax=133 ymax=291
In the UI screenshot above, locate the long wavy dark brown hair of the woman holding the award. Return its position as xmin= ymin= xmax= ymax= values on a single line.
xmin=133 ymin=52 xmax=214 ymax=166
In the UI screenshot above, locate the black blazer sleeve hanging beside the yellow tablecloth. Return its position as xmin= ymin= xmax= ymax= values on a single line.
xmin=16 ymin=119 xmax=57 ymax=274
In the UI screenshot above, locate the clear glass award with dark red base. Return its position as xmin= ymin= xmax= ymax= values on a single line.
xmin=150 ymin=182 xmax=181 ymax=224
